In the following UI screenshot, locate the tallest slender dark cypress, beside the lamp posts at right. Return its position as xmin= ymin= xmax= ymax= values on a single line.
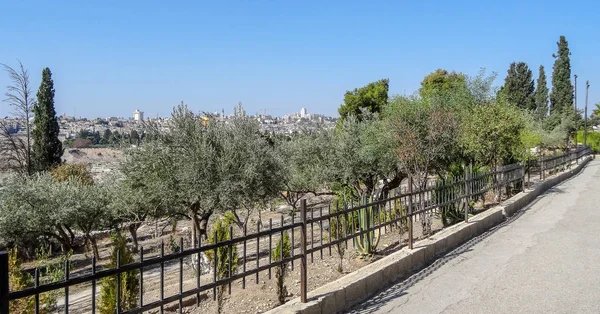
xmin=550 ymin=36 xmax=573 ymax=114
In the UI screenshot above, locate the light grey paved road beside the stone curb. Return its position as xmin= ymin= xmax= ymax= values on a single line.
xmin=351 ymin=159 xmax=600 ymax=314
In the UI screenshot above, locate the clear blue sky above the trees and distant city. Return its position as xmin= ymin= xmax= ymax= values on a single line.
xmin=0 ymin=0 xmax=600 ymax=117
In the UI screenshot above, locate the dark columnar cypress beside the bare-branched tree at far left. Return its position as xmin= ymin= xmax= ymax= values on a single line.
xmin=32 ymin=68 xmax=63 ymax=171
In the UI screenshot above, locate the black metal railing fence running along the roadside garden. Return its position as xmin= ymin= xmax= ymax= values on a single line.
xmin=0 ymin=147 xmax=590 ymax=313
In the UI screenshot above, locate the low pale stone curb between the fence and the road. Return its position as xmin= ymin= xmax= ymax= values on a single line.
xmin=266 ymin=157 xmax=592 ymax=314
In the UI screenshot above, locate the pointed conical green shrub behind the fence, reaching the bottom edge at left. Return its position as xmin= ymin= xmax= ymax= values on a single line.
xmin=98 ymin=233 xmax=139 ymax=314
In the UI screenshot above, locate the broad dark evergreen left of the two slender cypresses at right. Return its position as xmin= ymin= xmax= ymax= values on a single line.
xmin=500 ymin=62 xmax=535 ymax=111
